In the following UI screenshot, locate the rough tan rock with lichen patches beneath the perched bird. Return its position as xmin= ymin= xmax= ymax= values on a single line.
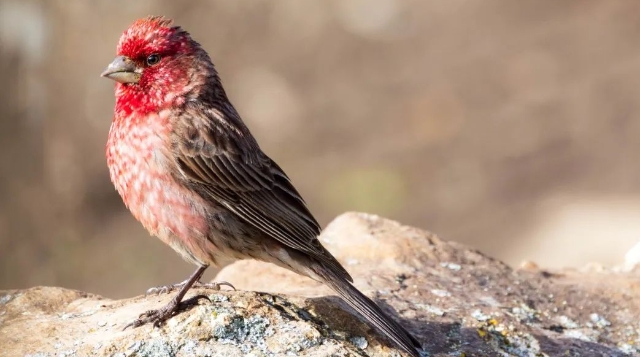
xmin=0 ymin=213 xmax=640 ymax=357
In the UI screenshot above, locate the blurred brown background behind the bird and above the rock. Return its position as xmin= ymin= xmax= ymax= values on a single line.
xmin=0 ymin=0 xmax=640 ymax=298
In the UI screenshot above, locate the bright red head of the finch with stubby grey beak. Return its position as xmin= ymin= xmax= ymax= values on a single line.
xmin=102 ymin=16 xmax=217 ymax=114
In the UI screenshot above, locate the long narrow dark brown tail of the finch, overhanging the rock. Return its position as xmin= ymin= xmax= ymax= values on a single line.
xmin=312 ymin=264 xmax=421 ymax=357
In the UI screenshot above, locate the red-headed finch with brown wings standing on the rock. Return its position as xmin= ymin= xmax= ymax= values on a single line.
xmin=102 ymin=17 xmax=420 ymax=356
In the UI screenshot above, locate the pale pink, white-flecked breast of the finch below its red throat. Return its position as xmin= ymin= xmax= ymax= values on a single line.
xmin=107 ymin=114 xmax=206 ymax=244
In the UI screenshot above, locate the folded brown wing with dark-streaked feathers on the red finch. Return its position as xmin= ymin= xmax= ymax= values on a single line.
xmin=172 ymin=104 xmax=351 ymax=280
